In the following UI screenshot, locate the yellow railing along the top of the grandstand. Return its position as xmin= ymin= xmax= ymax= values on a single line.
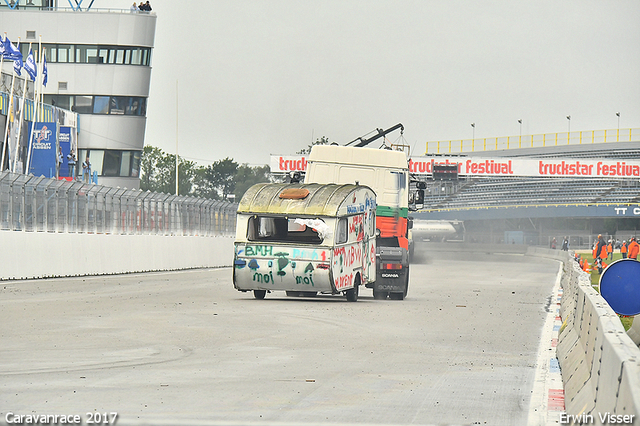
xmin=425 ymin=129 xmax=640 ymax=155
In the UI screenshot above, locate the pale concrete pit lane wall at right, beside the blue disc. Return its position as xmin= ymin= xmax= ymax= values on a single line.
xmin=527 ymin=247 xmax=640 ymax=424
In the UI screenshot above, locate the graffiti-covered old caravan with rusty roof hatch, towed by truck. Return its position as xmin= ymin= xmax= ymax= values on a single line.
xmin=233 ymin=183 xmax=376 ymax=302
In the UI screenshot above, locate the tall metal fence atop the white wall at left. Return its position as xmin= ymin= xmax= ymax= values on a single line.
xmin=0 ymin=171 xmax=238 ymax=236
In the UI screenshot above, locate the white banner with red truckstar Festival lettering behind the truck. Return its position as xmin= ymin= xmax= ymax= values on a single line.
xmin=270 ymin=155 xmax=640 ymax=178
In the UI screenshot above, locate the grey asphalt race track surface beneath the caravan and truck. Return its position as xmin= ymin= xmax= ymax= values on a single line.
xmin=0 ymin=248 xmax=559 ymax=425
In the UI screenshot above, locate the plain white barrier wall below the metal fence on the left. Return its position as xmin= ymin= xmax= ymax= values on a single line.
xmin=0 ymin=231 xmax=233 ymax=280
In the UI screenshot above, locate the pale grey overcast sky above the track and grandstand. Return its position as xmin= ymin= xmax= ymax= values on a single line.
xmin=111 ymin=0 xmax=640 ymax=165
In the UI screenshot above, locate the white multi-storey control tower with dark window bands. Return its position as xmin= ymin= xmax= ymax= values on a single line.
xmin=0 ymin=0 xmax=156 ymax=189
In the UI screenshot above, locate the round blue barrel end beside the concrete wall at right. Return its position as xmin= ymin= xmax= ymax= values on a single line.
xmin=600 ymin=259 xmax=640 ymax=316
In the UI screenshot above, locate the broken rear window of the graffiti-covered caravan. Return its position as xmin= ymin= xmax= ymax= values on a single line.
xmin=247 ymin=216 xmax=328 ymax=244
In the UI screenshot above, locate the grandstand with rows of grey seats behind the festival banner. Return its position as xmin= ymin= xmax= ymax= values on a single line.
xmin=414 ymin=129 xmax=640 ymax=244
